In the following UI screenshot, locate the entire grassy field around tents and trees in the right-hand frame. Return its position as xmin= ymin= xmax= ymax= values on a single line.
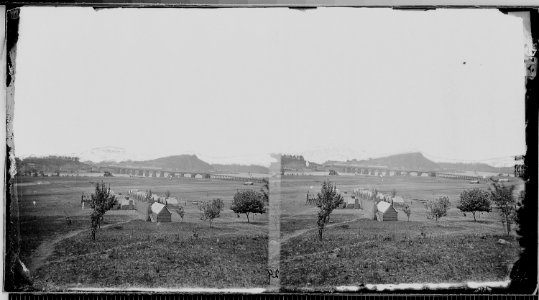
xmin=280 ymin=176 xmax=521 ymax=290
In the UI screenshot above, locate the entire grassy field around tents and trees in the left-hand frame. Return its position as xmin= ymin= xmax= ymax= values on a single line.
xmin=13 ymin=177 xmax=269 ymax=290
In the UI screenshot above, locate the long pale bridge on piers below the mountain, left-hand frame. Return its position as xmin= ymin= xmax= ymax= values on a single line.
xmin=98 ymin=166 xmax=264 ymax=183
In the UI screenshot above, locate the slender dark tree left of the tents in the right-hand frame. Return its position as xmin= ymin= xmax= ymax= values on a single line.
xmin=316 ymin=180 xmax=344 ymax=240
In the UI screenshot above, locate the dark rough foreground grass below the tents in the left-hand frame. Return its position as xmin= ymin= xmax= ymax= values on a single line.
xmin=34 ymin=220 xmax=269 ymax=290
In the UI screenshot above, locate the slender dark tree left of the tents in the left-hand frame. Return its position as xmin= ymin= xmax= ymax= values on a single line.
xmin=90 ymin=182 xmax=118 ymax=241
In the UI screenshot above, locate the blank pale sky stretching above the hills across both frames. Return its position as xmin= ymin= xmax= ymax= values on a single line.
xmin=14 ymin=7 xmax=526 ymax=165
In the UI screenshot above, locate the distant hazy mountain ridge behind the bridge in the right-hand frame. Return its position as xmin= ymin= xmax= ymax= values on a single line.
xmin=324 ymin=152 xmax=513 ymax=173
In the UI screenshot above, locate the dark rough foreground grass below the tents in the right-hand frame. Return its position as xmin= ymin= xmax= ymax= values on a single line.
xmin=281 ymin=220 xmax=519 ymax=289
